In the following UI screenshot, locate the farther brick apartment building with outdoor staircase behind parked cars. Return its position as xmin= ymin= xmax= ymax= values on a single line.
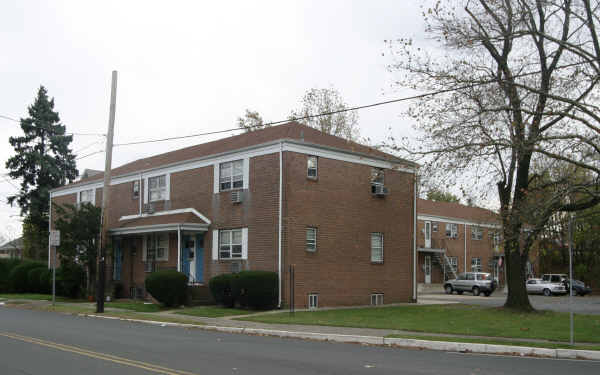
xmin=417 ymin=199 xmax=504 ymax=290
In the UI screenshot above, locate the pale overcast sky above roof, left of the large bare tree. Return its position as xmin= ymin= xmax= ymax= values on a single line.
xmin=0 ymin=0 xmax=423 ymax=237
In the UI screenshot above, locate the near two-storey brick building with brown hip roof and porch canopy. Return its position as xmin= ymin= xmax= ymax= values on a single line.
xmin=51 ymin=123 xmax=416 ymax=308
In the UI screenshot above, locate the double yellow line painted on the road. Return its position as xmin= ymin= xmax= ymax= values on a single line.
xmin=0 ymin=332 xmax=202 ymax=375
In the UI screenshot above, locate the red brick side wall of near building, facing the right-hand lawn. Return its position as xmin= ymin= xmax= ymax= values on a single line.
xmin=283 ymin=153 xmax=413 ymax=308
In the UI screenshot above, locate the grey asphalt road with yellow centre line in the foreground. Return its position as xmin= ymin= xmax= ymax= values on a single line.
xmin=0 ymin=307 xmax=600 ymax=375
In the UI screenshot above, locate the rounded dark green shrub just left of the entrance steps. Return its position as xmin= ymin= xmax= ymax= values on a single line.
xmin=146 ymin=270 xmax=188 ymax=307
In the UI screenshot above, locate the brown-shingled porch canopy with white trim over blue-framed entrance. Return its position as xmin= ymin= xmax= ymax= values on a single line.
xmin=109 ymin=208 xmax=211 ymax=235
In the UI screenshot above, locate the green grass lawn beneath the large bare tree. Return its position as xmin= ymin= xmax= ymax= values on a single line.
xmin=238 ymin=305 xmax=600 ymax=343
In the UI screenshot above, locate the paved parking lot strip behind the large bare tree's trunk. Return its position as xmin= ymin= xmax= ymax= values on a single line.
xmin=419 ymin=291 xmax=600 ymax=315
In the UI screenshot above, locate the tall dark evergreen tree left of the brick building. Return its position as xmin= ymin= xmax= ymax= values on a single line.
xmin=6 ymin=86 xmax=77 ymax=259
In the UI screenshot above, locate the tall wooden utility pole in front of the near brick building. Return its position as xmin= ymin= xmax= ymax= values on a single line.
xmin=96 ymin=70 xmax=117 ymax=313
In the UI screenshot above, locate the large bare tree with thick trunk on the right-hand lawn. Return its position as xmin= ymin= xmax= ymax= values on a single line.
xmin=389 ymin=0 xmax=600 ymax=310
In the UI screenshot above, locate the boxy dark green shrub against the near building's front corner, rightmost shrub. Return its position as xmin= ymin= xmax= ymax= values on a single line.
xmin=232 ymin=271 xmax=279 ymax=310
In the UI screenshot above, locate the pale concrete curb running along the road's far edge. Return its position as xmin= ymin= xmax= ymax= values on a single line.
xmin=77 ymin=314 xmax=600 ymax=361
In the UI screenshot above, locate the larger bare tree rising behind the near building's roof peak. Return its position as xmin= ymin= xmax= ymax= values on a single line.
xmin=290 ymin=88 xmax=359 ymax=141
